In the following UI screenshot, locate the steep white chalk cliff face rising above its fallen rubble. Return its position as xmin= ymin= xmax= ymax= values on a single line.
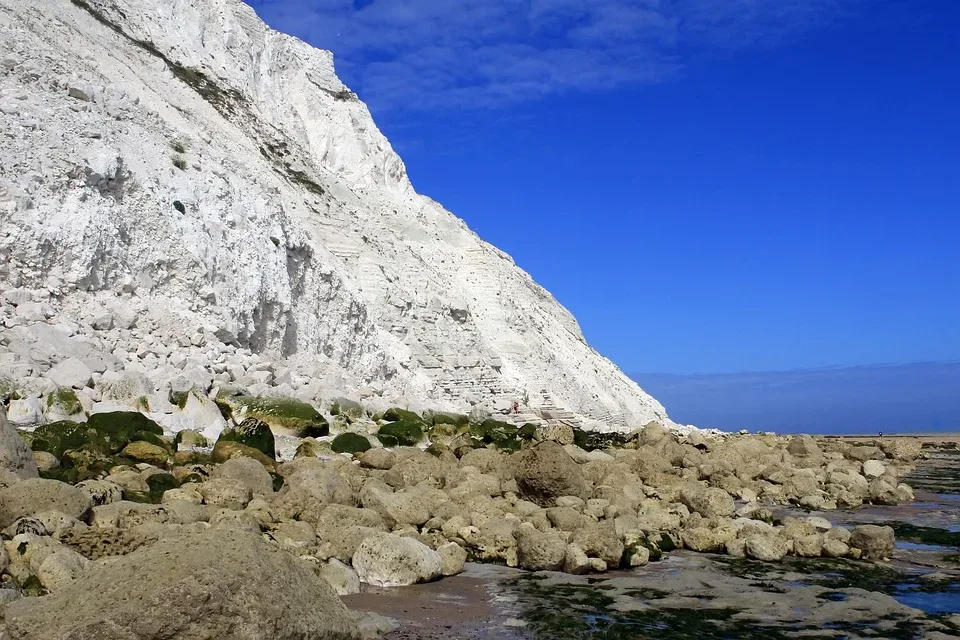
xmin=0 ymin=0 xmax=668 ymax=430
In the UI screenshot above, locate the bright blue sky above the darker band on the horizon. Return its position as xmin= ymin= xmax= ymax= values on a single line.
xmin=251 ymin=0 xmax=960 ymax=373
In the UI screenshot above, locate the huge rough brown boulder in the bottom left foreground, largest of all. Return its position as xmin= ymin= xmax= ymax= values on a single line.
xmin=4 ymin=526 xmax=356 ymax=640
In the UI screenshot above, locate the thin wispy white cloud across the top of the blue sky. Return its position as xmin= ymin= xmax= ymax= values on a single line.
xmin=248 ymin=0 xmax=865 ymax=111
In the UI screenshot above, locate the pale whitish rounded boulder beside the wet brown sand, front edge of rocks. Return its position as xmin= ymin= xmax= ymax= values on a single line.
xmin=353 ymin=533 xmax=443 ymax=587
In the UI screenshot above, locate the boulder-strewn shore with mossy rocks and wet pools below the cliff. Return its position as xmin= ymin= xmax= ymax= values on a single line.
xmin=0 ymin=390 xmax=960 ymax=640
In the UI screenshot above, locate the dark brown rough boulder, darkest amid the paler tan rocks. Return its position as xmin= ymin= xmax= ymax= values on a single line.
xmin=514 ymin=442 xmax=588 ymax=507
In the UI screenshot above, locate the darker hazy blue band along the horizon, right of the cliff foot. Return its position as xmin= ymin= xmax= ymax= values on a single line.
xmin=633 ymin=362 xmax=960 ymax=435
